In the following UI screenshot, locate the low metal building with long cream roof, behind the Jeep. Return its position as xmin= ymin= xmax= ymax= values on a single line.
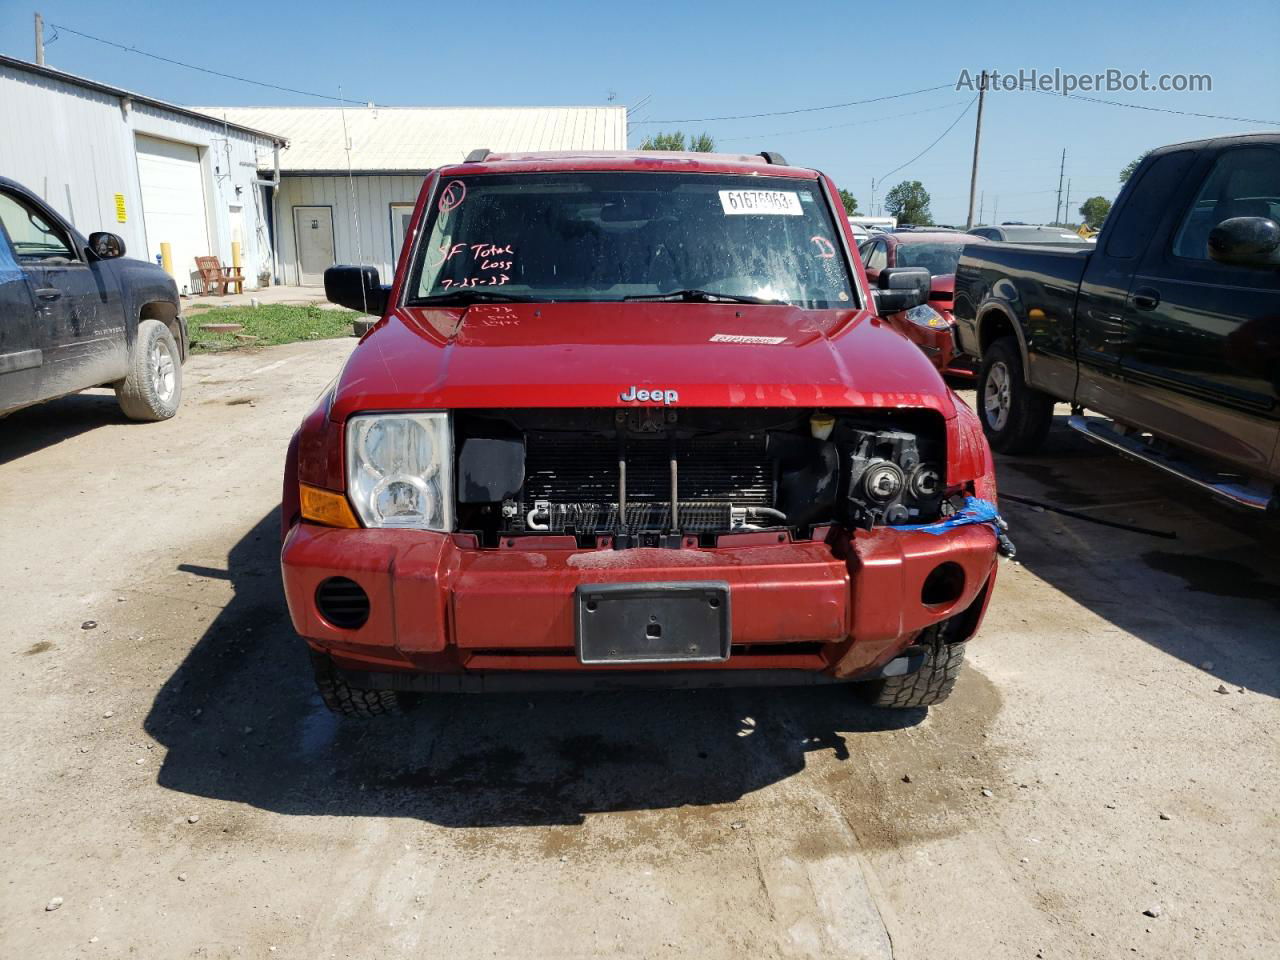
xmin=198 ymin=106 xmax=627 ymax=284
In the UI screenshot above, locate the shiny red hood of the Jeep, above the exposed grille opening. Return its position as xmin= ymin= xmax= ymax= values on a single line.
xmin=330 ymin=302 xmax=955 ymax=420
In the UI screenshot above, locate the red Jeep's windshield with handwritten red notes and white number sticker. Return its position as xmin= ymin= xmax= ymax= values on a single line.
xmin=408 ymin=172 xmax=858 ymax=308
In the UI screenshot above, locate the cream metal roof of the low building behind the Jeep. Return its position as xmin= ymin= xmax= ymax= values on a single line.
xmin=196 ymin=106 xmax=627 ymax=173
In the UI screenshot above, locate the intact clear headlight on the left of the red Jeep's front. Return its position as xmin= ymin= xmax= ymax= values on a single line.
xmin=347 ymin=413 xmax=453 ymax=531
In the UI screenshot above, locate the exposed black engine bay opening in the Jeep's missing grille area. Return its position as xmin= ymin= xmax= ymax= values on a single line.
xmin=453 ymin=407 xmax=954 ymax=548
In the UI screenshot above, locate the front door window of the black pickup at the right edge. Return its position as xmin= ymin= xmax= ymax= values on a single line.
xmin=1174 ymin=147 xmax=1280 ymax=260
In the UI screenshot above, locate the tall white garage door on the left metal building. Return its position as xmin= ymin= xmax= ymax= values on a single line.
xmin=137 ymin=136 xmax=209 ymax=292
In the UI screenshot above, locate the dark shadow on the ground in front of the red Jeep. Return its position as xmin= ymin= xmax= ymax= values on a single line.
xmin=145 ymin=512 xmax=925 ymax=827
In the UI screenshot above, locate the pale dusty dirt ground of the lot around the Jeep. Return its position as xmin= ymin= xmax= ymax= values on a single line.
xmin=0 ymin=340 xmax=1280 ymax=960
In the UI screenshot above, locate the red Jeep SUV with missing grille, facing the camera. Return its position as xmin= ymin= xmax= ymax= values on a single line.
xmin=282 ymin=151 xmax=1007 ymax=714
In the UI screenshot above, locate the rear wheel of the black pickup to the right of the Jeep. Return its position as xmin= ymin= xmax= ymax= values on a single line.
xmin=978 ymin=337 xmax=1053 ymax=453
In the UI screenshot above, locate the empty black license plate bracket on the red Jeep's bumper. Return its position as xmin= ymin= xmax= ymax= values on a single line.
xmin=573 ymin=580 xmax=732 ymax=664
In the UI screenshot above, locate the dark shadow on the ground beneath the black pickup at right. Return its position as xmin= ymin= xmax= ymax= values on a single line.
xmin=995 ymin=417 xmax=1280 ymax=696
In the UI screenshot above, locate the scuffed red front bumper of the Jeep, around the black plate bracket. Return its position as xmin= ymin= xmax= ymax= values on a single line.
xmin=282 ymin=524 xmax=995 ymax=677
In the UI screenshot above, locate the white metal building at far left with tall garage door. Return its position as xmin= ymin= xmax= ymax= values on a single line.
xmin=0 ymin=56 xmax=285 ymax=292
